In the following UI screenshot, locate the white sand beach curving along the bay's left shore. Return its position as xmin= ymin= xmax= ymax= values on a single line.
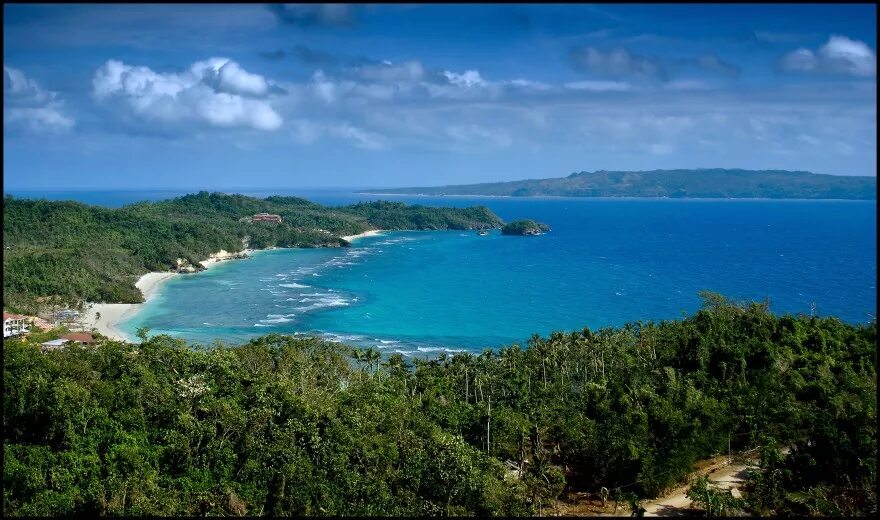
xmin=85 ymin=249 xmax=255 ymax=342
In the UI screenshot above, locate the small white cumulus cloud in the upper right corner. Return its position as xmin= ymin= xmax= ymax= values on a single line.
xmin=779 ymin=35 xmax=877 ymax=77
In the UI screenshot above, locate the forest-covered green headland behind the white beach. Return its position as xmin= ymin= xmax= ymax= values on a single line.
xmin=3 ymin=192 xmax=502 ymax=314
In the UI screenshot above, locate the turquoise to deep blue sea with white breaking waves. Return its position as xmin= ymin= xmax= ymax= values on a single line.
xmin=5 ymin=190 xmax=877 ymax=355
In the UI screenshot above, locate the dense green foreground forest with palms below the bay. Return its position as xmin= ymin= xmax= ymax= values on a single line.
xmin=3 ymin=294 xmax=877 ymax=516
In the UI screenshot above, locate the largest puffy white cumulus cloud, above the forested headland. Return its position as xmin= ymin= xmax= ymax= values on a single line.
xmin=92 ymin=58 xmax=283 ymax=130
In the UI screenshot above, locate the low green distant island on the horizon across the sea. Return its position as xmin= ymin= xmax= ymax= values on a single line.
xmin=360 ymin=168 xmax=877 ymax=200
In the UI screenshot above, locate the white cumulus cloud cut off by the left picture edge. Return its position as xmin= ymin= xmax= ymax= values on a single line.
xmin=3 ymin=65 xmax=74 ymax=133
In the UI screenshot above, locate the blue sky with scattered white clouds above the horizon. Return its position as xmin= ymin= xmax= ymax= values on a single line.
xmin=3 ymin=4 xmax=877 ymax=190
